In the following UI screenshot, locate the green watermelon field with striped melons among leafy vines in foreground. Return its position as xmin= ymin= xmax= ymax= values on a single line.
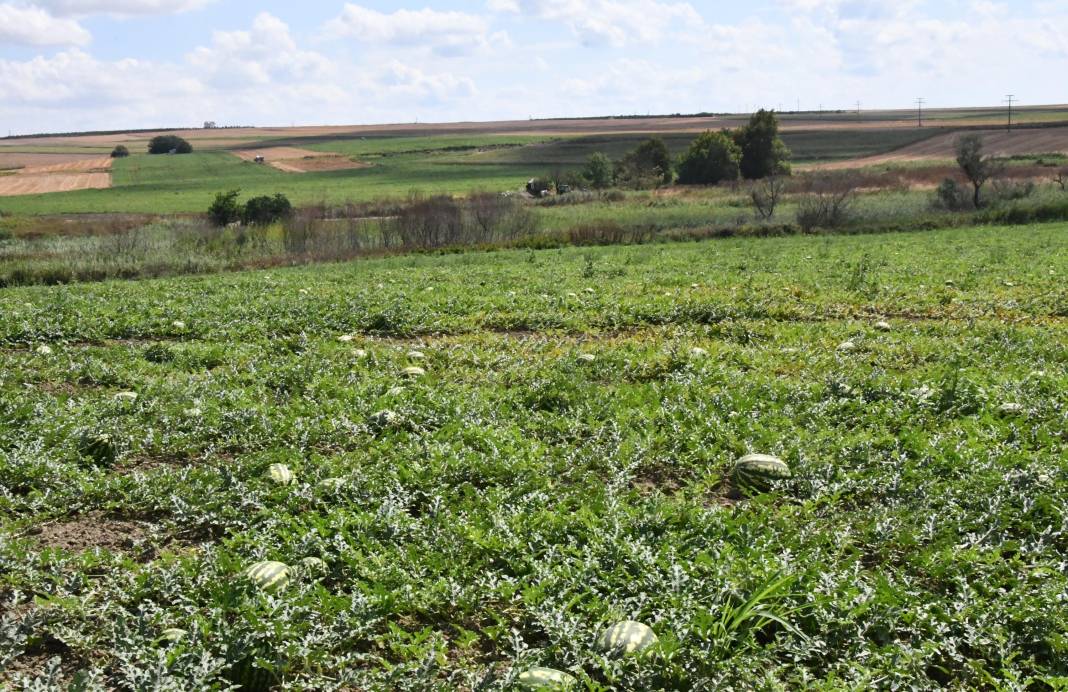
xmin=0 ymin=224 xmax=1068 ymax=691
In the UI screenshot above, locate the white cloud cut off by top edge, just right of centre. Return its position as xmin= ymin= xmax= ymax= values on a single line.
xmin=488 ymin=0 xmax=704 ymax=47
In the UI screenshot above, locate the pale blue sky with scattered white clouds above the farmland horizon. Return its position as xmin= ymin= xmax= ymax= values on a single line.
xmin=0 ymin=0 xmax=1068 ymax=136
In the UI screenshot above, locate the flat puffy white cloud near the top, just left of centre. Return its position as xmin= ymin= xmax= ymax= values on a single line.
xmin=324 ymin=3 xmax=507 ymax=56
